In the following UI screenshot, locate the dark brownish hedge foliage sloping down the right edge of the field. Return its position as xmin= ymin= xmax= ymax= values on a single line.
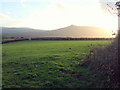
xmin=82 ymin=31 xmax=120 ymax=88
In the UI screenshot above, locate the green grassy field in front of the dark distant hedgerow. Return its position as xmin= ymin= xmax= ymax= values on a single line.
xmin=2 ymin=40 xmax=111 ymax=88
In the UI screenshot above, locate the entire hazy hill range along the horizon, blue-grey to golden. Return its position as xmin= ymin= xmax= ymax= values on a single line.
xmin=2 ymin=25 xmax=112 ymax=38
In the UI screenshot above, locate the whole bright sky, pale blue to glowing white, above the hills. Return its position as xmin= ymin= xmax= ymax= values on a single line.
xmin=0 ymin=0 xmax=118 ymax=31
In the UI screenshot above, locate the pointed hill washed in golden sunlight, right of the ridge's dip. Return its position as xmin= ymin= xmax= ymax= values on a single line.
xmin=45 ymin=25 xmax=112 ymax=37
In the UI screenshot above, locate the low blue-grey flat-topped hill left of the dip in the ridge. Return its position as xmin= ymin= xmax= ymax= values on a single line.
xmin=2 ymin=27 xmax=45 ymax=37
